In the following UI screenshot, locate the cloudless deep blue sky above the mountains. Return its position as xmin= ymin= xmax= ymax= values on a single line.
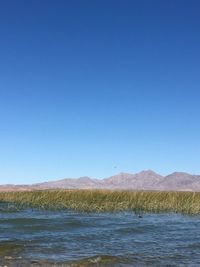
xmin=0 ymin=0 xmax=200 ymax=184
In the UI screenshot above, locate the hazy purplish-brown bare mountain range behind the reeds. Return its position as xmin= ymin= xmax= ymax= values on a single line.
xmin=0 ymin=170 xmax=200 ymax=191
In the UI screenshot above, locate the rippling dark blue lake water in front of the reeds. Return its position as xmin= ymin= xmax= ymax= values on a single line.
xmin=0 ymin=204 xmax=200 ymax=267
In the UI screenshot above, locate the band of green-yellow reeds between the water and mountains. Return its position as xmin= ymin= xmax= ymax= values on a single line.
xmin=0 ymin=190 xmax=200 ymax=215
